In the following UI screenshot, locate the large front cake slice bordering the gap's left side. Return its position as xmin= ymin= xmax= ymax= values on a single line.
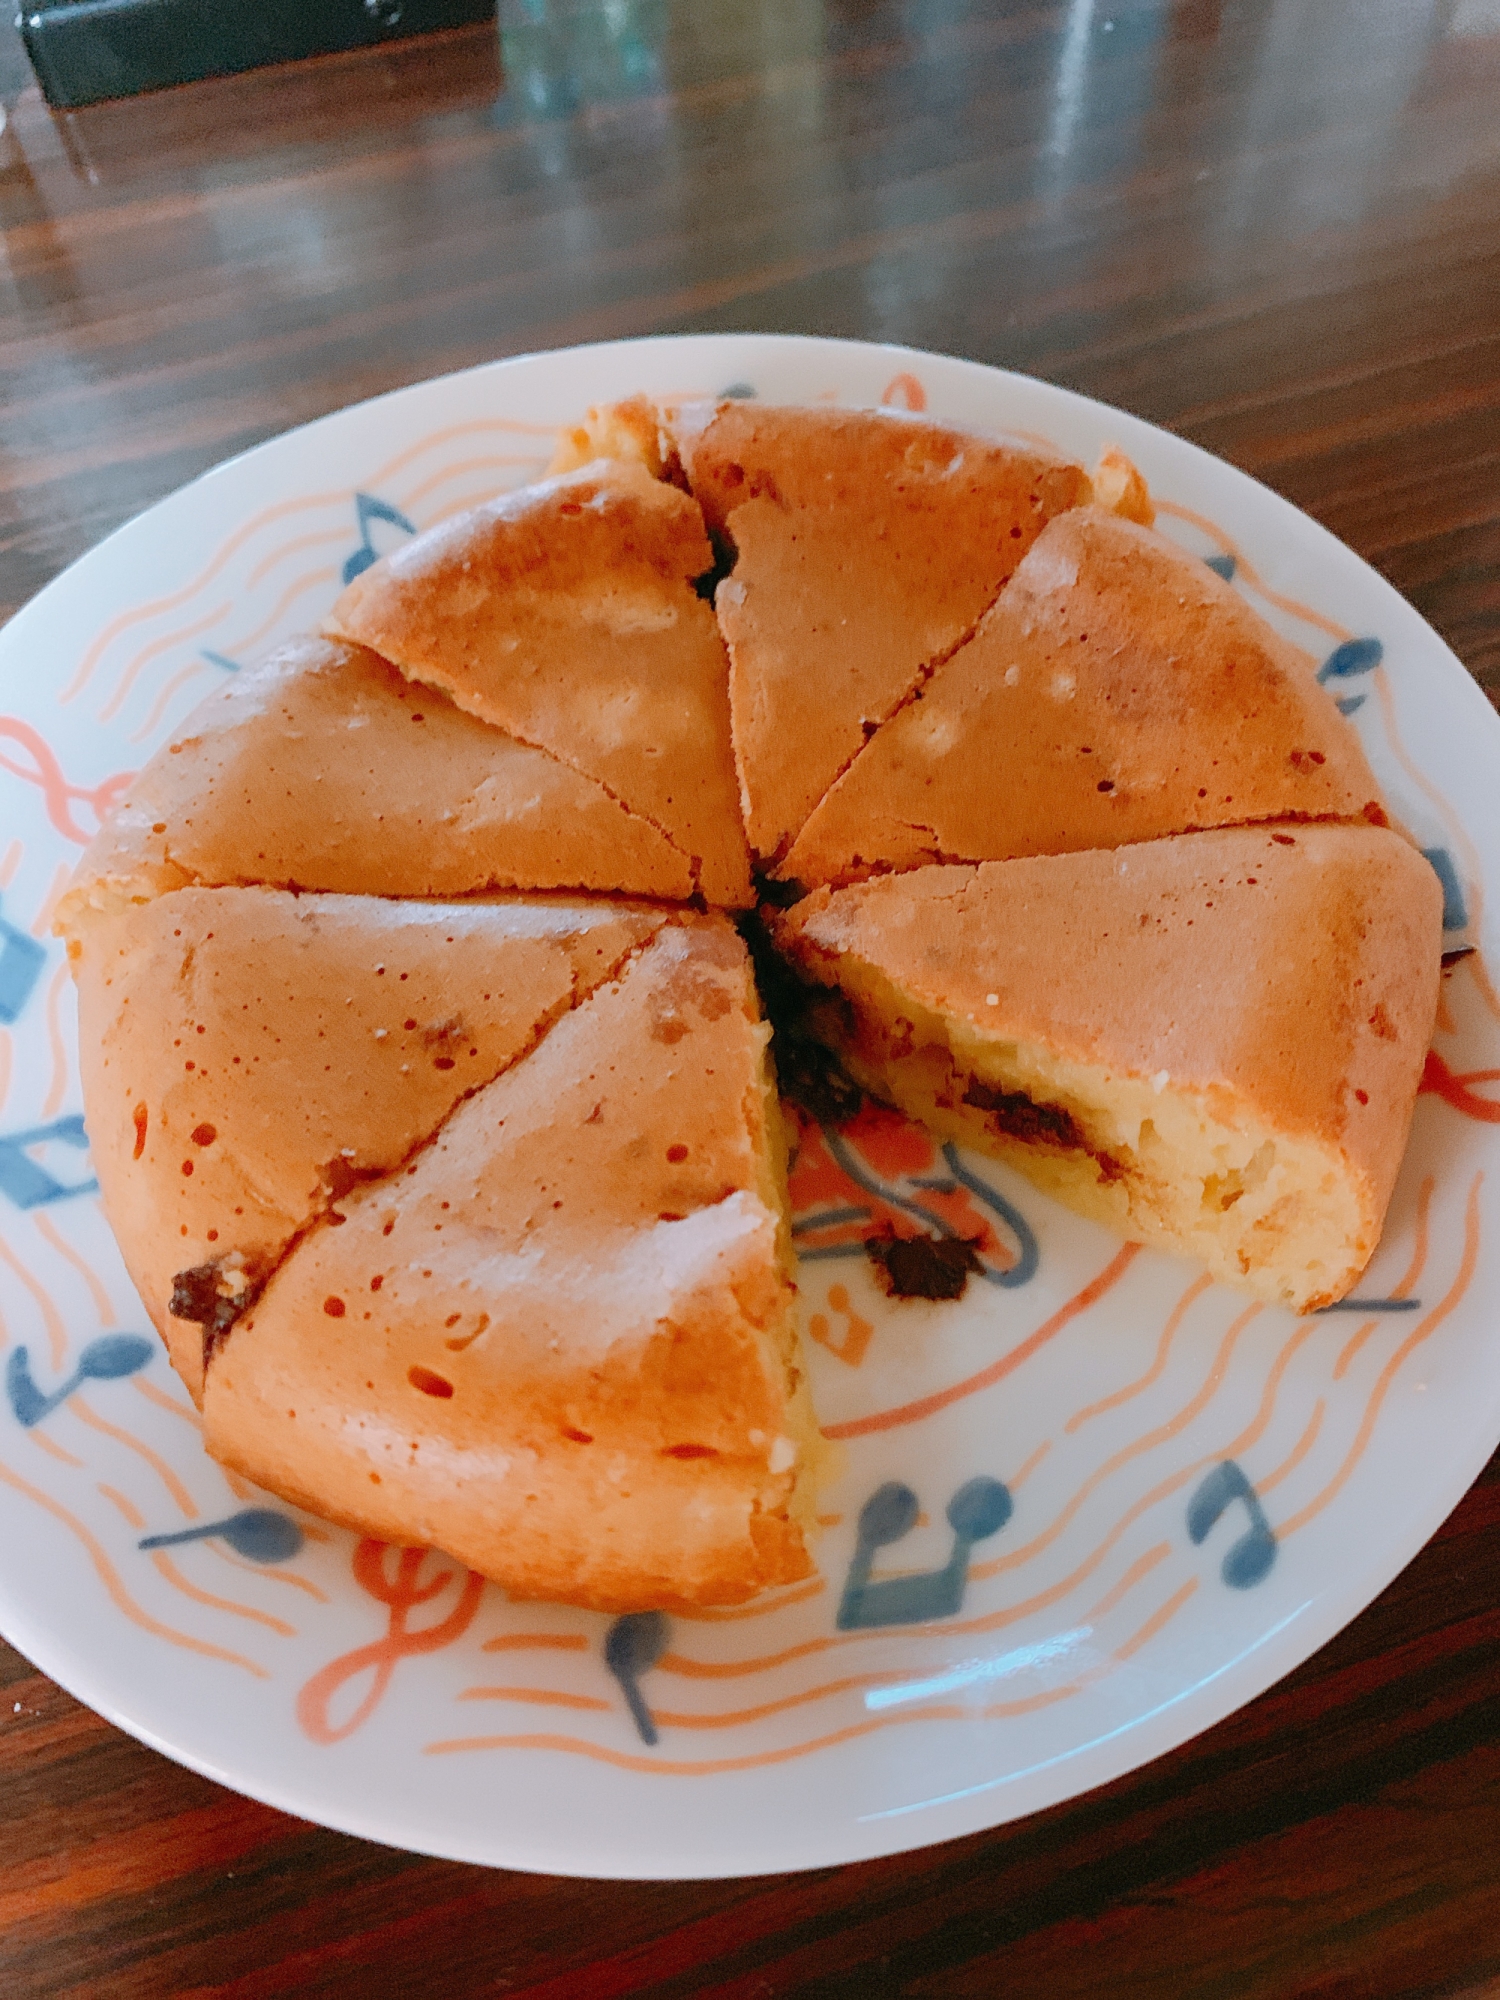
xmin=204 ymin=918 xmax=818 ymax=1610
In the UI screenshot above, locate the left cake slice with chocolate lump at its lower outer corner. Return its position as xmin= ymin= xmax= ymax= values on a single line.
xmin=70 ymin=888 xmax=664 ymax=1396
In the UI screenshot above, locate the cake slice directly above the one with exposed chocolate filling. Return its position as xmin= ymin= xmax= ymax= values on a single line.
xmin=782 ymin=508 xmax=1384 ymax=888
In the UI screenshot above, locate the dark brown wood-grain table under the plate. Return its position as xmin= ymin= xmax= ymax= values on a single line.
xmin=0 ymin=0 xmax=1500 ymax=2000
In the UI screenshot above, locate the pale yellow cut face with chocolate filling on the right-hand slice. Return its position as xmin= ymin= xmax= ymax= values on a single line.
xmin=810 ymin=958 xmax=1376 ymax=1312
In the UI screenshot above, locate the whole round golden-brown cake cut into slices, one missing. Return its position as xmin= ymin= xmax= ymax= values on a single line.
xmin=58 ymin=398 xmax=1442 ymax=1610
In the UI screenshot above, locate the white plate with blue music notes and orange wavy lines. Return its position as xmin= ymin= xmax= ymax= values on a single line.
xmin=0 ymin=336 xmax=1500 ymax=1876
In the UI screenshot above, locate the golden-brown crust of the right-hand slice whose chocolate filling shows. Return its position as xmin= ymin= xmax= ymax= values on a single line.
xmin=776 ymin=826 xmax=1442 ymax=1292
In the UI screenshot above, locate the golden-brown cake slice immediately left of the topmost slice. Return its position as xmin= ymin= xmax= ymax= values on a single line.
xmin=328 ymin=460 xmax=750 ymax=906
